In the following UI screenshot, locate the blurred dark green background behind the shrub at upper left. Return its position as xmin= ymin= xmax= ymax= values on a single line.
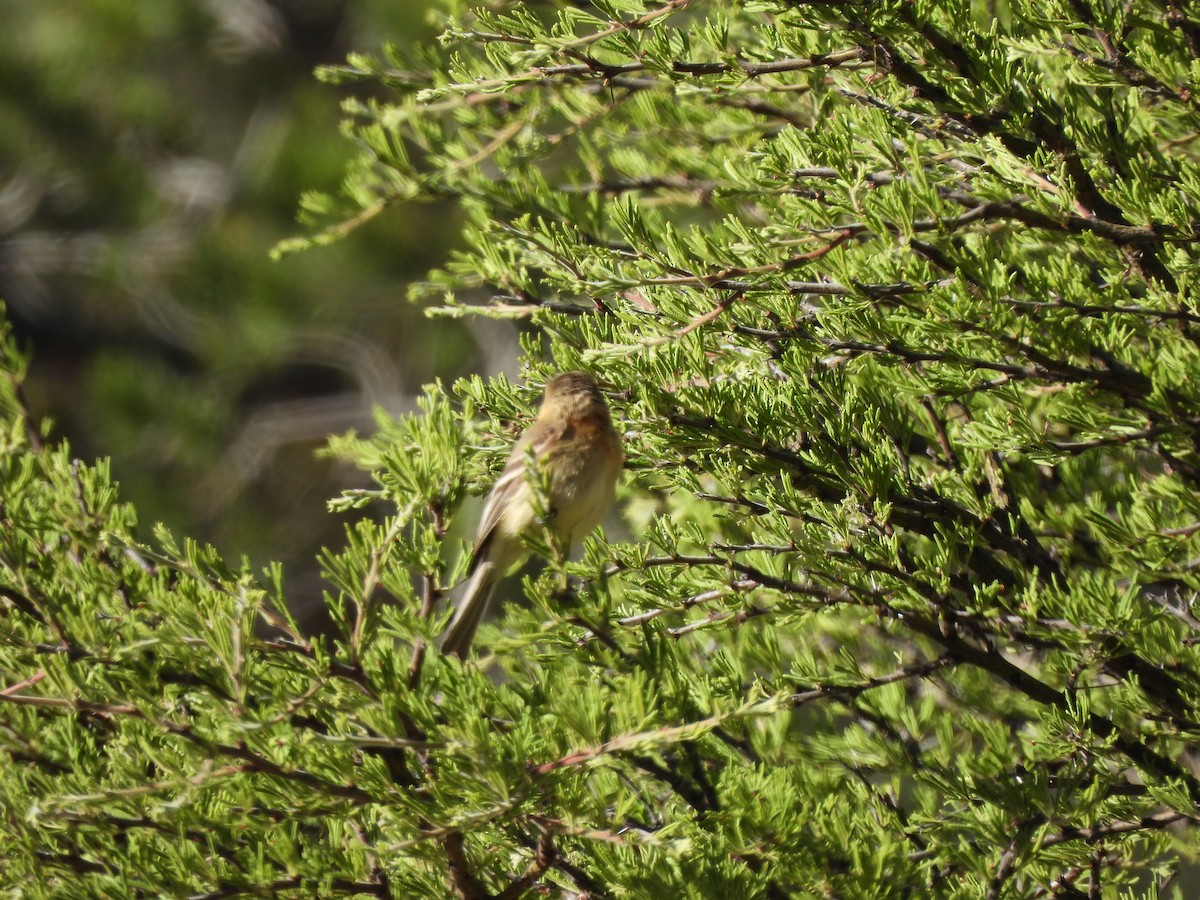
xmin=0 ymin=0 xmax=504 ymax=628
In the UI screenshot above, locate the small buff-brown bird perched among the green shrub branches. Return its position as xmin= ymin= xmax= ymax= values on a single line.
xmin=440 ymin=372 xmax=625 ymax=659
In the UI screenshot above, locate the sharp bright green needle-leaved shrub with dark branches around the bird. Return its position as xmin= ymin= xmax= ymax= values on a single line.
xmin=7 ymin=0 xmax=1200 ymax=898
